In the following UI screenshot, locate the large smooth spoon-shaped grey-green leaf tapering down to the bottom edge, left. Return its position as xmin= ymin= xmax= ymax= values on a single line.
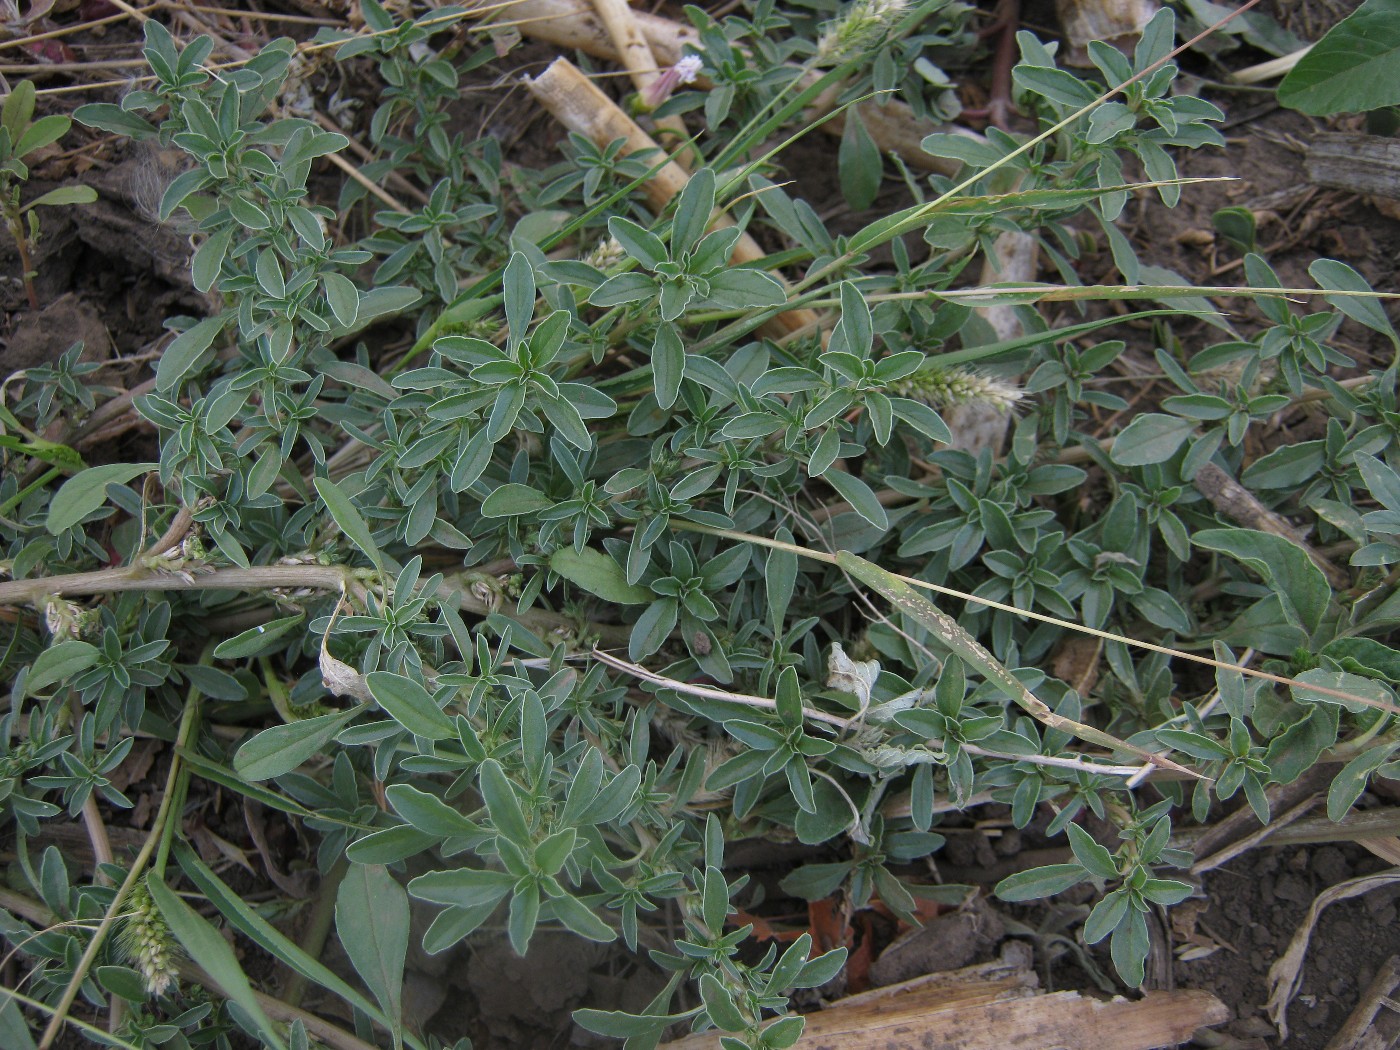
xmin=336 ymin=864 xmax=409 ymax=1047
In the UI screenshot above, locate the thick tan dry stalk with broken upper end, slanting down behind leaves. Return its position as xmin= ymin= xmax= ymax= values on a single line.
xmin=525 ymin=59 xmax=818 ymax=336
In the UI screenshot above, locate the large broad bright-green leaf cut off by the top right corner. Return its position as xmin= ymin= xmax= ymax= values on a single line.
xmin=1278 ymin=0 xmax=1400 ymax=116
